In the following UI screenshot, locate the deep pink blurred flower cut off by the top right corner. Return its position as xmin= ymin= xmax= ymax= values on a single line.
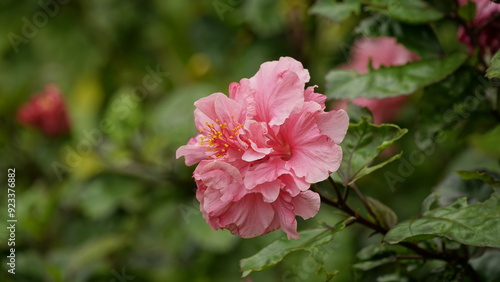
xmin=458 ymin=0 xmax=500 ymax=55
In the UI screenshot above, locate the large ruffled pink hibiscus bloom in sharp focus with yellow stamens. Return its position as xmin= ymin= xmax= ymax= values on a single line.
xmin=176 ymin=57 xmax=349 ymax=238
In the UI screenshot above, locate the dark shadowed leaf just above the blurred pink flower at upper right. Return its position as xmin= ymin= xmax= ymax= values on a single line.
xmin=356 ymin=16 xmax=443 ymax=60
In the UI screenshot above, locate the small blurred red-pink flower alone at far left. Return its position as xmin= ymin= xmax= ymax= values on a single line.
xmin=17 ymin=84 xmax=70 ymax=136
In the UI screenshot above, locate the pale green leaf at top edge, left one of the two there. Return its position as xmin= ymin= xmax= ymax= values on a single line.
xmin=309 ymin=0 xmax=361 ymax=23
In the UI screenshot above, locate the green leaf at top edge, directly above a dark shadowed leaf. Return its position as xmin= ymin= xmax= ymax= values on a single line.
xmin=368 ymin=0 xmax=444 ymax=24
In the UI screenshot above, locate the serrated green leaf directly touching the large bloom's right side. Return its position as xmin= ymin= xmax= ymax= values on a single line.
xmin=337 ymin=118 xmax=408 ymax=185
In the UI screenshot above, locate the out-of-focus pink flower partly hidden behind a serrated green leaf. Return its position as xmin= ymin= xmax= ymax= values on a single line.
xmin=334 ymin=37 xmax=418 ymax=124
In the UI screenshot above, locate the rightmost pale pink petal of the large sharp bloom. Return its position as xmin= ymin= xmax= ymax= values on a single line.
xmin=315 ymin=110 xmax=349 ymax=144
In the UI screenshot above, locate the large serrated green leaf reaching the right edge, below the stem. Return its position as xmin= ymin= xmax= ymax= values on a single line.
xmin=384 ymin=193 xmax=500 ymax=248
